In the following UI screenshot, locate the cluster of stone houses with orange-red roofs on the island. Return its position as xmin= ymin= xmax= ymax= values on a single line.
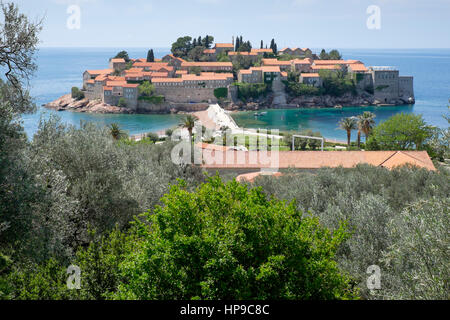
xmin=83 ymin=39 xmax=414 ymax=111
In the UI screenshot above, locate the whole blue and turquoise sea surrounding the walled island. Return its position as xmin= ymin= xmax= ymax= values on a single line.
xmin=22 ymin=48 xmax=450 ymax=140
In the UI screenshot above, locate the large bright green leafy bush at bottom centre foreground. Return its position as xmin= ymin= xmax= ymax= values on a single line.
xmin=114 ymin=177 xmax=354 ymax=300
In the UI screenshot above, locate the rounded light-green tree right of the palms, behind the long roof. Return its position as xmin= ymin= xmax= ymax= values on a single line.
xmin=370 ymin=112 xmax=433 ymax=150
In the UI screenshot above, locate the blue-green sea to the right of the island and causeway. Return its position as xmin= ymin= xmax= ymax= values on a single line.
xmin=233 ymin=49 xmax=450 ymax=140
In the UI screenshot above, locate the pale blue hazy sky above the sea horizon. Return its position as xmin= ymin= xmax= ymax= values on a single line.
xmin=10 ymin=0 xmax=450 ymax=49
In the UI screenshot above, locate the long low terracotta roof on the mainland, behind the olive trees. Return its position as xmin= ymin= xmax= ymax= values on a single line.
xmin=198 ymin=150 xmax=436 ymax=171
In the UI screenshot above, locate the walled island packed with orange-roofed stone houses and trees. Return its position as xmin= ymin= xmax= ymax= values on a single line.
xmin=45 ymin=36 xmax=415 ymax=113
